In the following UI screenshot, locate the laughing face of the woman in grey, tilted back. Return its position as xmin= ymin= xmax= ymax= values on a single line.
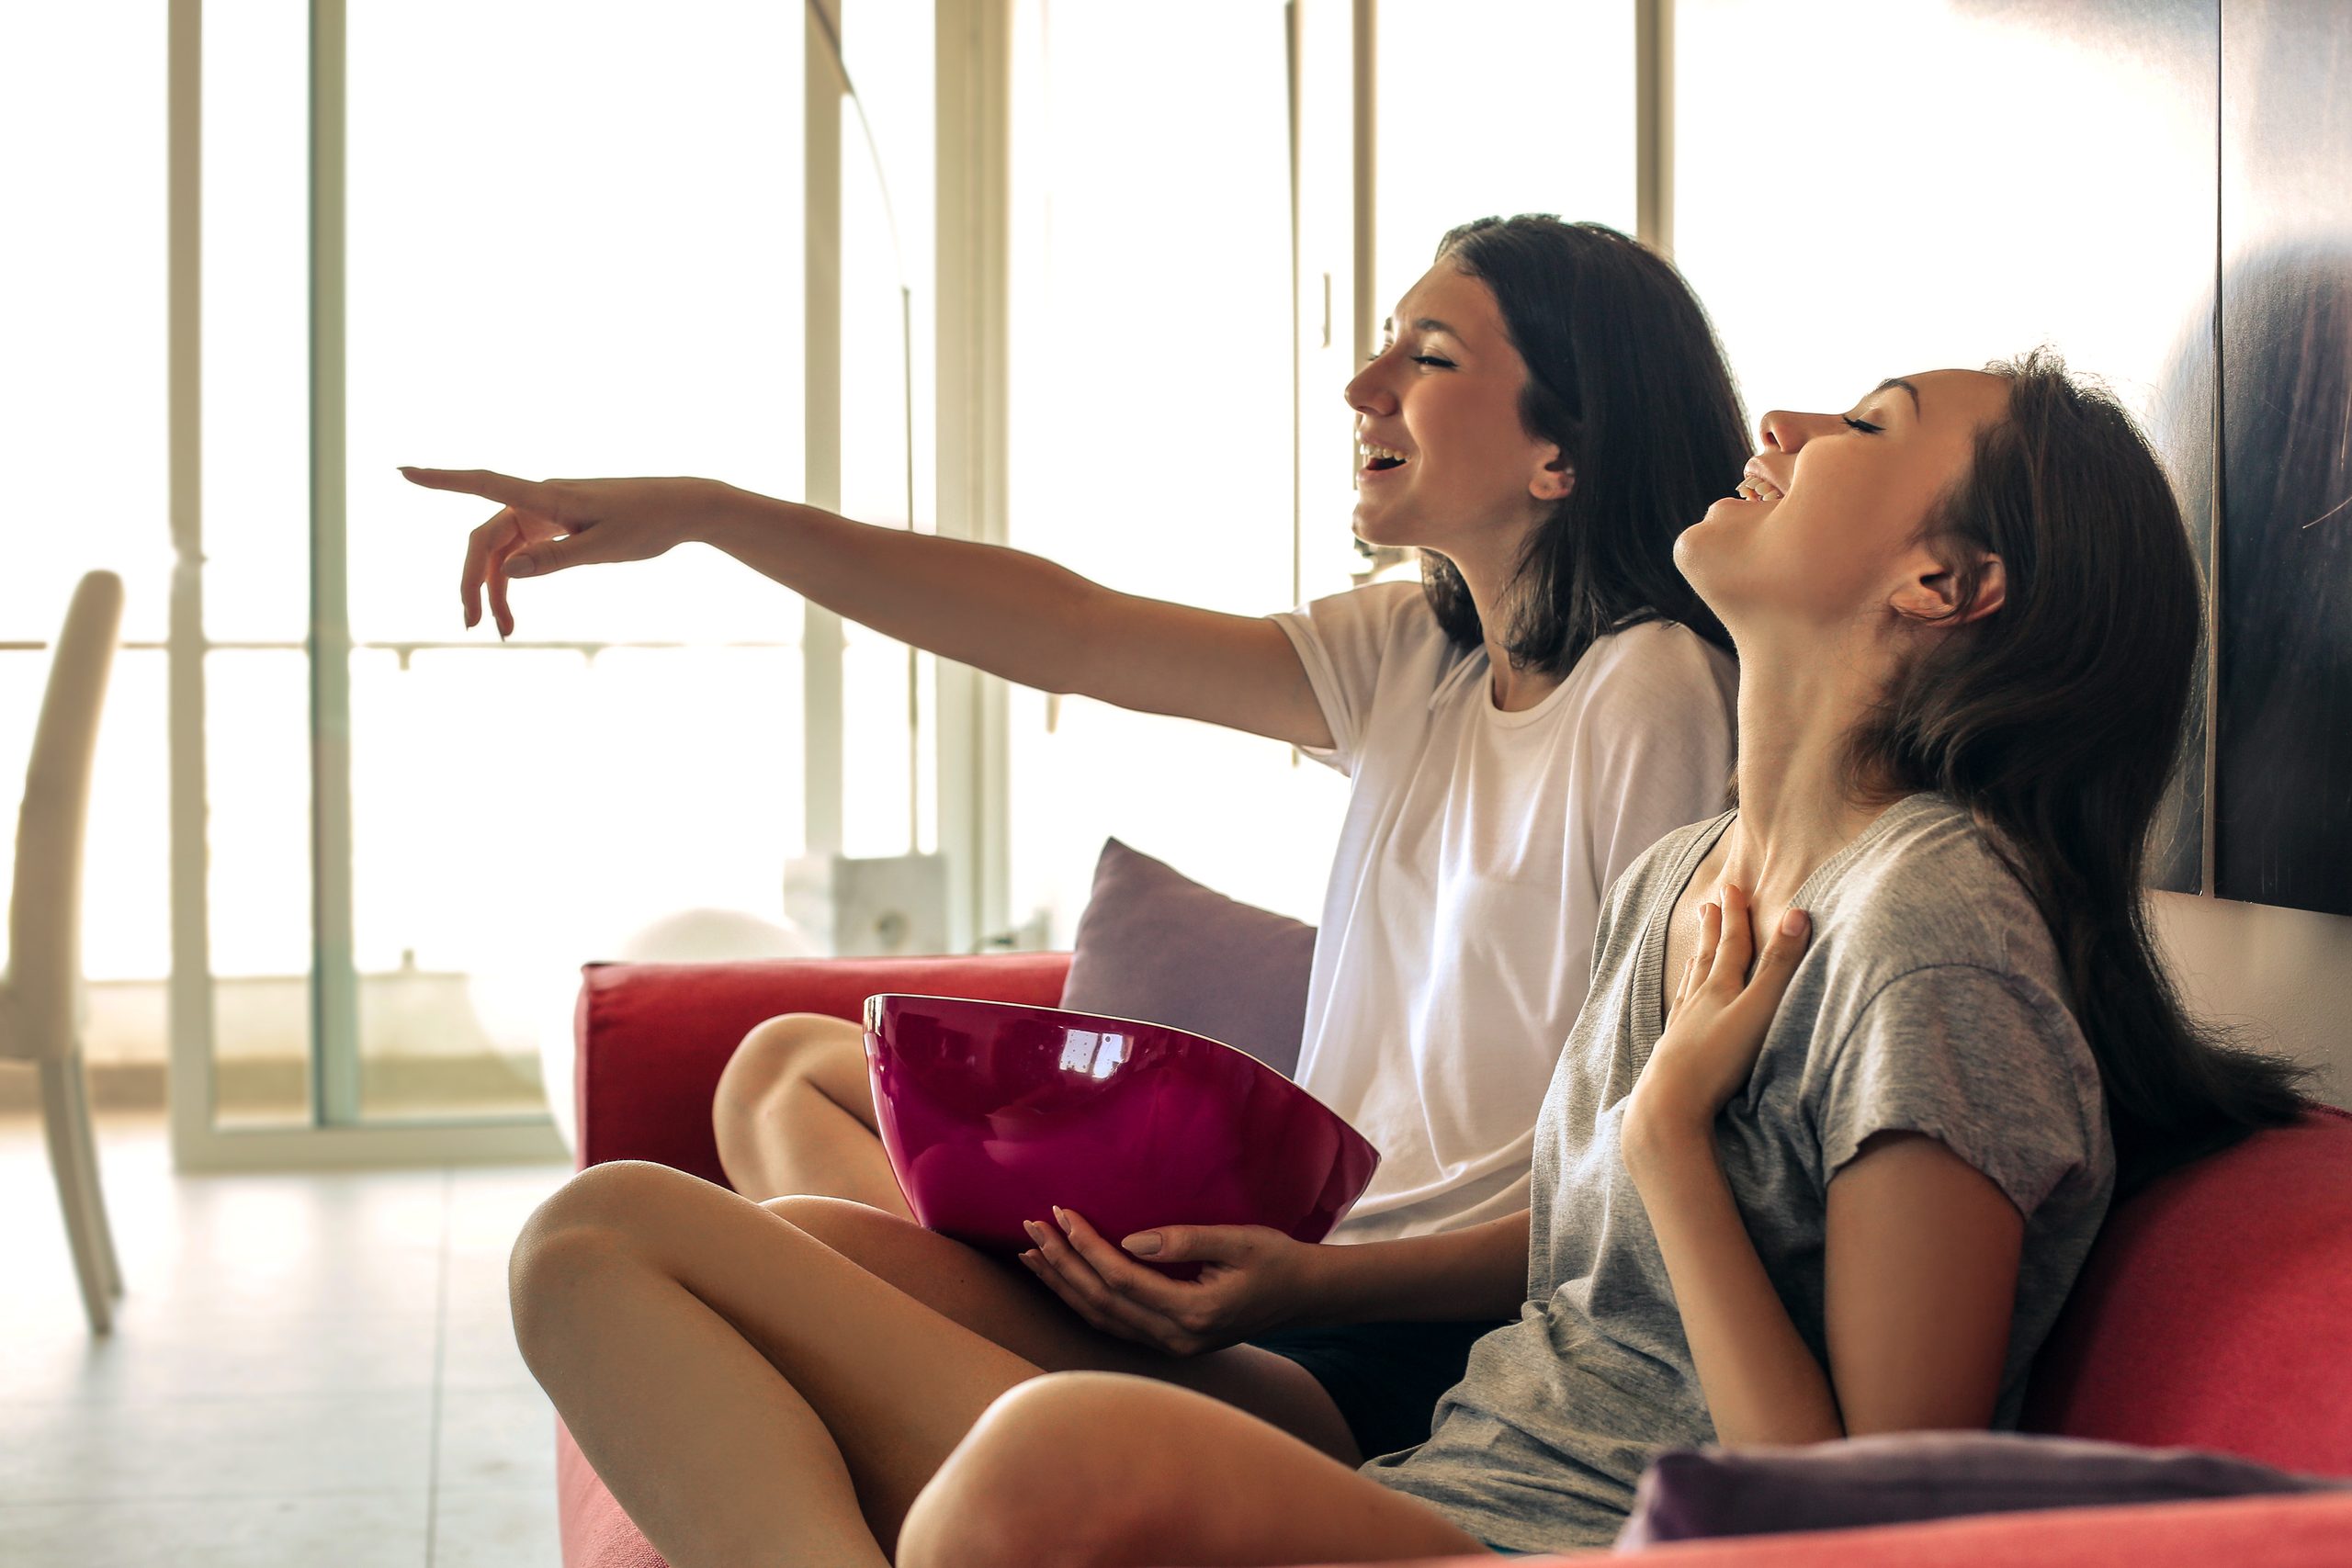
xmin=1675 ymin=369 xmax=2008 ymax=639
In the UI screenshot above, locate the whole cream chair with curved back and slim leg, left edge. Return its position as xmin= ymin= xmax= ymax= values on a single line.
xmin=0 ymin=571 xmax=122 ymax=1333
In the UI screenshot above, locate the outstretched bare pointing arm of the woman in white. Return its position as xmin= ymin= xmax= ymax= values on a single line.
xmin=402 ymin=468 xmax=1331 ymax=748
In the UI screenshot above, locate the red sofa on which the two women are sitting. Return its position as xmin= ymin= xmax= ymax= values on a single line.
xmin=555 ymin=954 xmax=2352 ymax=1568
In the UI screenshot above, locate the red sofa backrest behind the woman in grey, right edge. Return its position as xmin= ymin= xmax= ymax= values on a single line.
xmin=2025 ymin=1107 xmax=2352 ymax=1476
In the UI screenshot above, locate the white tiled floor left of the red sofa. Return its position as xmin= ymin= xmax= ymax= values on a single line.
xmin=0 ymin=1117 xmax=564 ymax=1568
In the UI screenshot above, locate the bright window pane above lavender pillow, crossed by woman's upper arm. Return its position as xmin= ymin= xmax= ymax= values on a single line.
xmin=1009 ymin=0 xmax=1348 ymax=942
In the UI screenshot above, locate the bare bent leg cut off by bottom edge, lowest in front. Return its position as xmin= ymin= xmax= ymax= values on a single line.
xmin=899 ymin=1373 xmax=1484 ymax=1568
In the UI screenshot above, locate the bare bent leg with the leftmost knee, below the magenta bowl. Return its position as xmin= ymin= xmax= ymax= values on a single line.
xmin=513 ymin=1164 xmax=1037 ymax=1568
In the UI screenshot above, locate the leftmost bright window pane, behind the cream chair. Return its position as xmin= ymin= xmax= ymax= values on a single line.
xmin=0 ymin=5 xmax=172 ymax=1109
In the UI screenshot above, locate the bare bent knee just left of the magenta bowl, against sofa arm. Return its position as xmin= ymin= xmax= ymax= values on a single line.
xmin=710 ymin=1013 xmax=912 ymax=1220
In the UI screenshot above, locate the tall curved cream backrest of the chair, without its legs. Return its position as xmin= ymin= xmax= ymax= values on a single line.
xmin=7 ymin=571 xmax=122 ymax=1055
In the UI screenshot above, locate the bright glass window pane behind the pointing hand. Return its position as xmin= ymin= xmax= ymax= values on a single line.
xmin=322 ymin=0 xmax=802 ymax=1117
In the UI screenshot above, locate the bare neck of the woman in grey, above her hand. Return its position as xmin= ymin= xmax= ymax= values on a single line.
xmin=1724 ymin=629 xmax=1886 ymax=921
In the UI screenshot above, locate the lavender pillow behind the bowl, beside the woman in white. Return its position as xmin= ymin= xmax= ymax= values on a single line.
xmin=1061 ymin=840 xmax=1315 ymax=1075
